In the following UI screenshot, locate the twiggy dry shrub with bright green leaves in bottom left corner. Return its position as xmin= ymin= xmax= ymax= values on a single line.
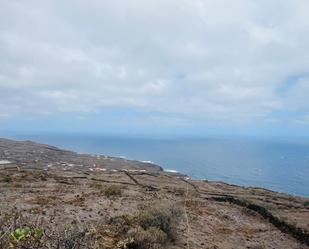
xmin=0 ymin=209 xmax=97 ymax=249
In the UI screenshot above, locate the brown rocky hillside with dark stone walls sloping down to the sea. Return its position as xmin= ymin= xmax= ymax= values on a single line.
xmin=0 ymin=139 xmax=309 ymax=249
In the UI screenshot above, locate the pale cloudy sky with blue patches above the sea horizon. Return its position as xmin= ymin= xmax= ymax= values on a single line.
xmin=0 ymin=0 xmax=309 ymax=136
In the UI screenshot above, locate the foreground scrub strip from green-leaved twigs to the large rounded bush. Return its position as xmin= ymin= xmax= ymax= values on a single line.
xmin=0 ymin=201 xmax=181 ymax=249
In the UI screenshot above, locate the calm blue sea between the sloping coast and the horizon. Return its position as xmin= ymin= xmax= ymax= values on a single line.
xmin=3 ymin=134 xmax=309 ymax=197
